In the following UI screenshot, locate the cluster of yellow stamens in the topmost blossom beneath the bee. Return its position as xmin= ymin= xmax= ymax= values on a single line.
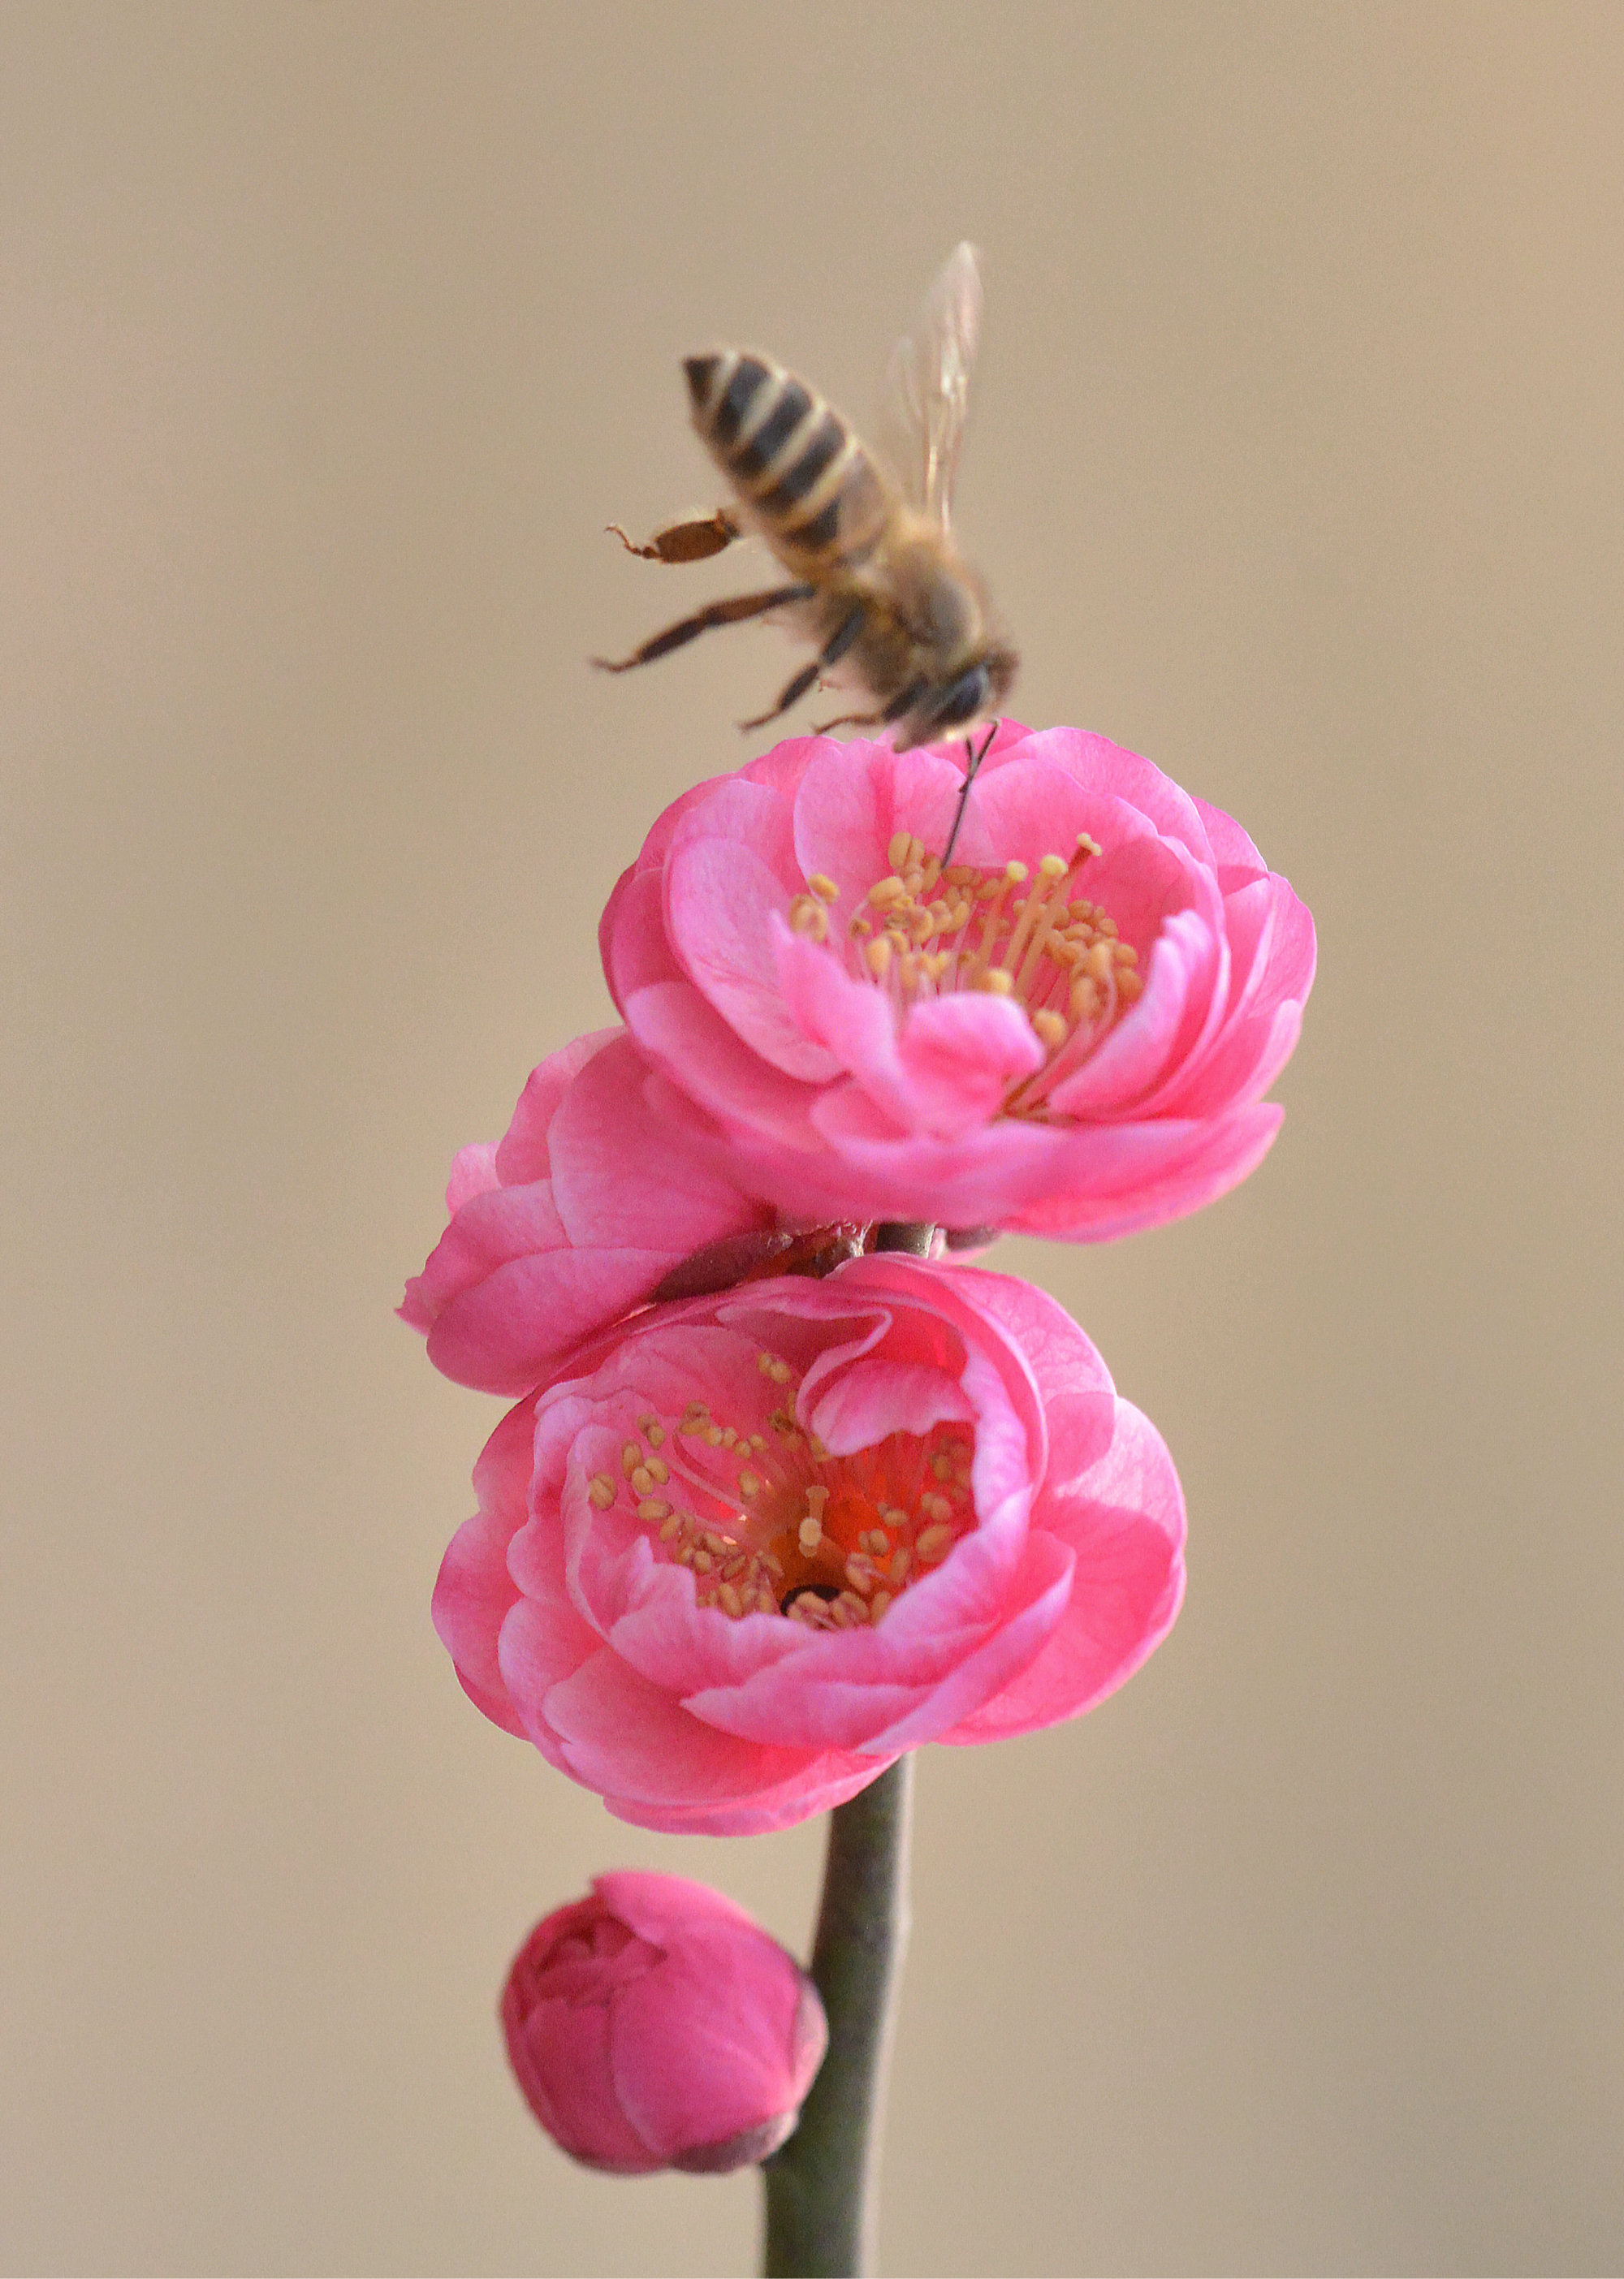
xmin=790 ymin=832 xmax=1143 ymax=1115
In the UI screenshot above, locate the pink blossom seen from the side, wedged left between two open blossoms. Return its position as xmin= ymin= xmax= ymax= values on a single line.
xmin=401 ymin=1028 xmax=772 ymax=1395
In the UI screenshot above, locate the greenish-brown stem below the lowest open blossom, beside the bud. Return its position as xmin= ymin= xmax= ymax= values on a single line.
xmin=761 ymin=1757 xmax=914 ymax=2279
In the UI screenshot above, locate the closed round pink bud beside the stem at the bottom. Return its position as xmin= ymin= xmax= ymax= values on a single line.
xmin=501 ymin=1869 xmax=829 ymax=2177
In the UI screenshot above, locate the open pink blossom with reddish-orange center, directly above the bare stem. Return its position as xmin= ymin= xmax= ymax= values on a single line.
xmin=435 ymin=1254 xmax=1185 ymax=1835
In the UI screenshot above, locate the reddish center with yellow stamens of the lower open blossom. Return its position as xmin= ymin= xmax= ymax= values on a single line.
xmin=588 ymin=1352 xmax=975 ymax=1629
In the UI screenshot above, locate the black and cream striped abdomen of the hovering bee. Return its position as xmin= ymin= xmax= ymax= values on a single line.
xmin=684 ymin=348 xmax=891 ymax=576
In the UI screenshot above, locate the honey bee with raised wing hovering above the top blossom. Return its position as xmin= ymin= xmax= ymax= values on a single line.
xmin=594 ymin=246 xmax=1018 ymax=756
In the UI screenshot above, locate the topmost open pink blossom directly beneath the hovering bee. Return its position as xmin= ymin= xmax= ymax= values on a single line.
xmin=599 ymin=723 xmax=1315 ymax=1240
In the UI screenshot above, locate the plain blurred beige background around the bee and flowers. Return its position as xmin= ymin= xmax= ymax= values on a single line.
xmin=0 ymin=5 xmax=1624 ymax=2273
